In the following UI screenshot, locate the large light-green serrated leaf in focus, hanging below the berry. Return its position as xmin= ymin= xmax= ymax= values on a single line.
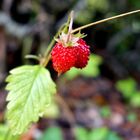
xmin=6 ymin=65 xmax=56 ymax=135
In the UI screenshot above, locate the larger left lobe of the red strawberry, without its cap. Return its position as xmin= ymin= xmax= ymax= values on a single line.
xmin=51 ymin=43 xmax=77 ymax=73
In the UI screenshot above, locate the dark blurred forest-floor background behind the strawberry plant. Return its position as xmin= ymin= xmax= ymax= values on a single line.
xmin=0 ymin=0 xmax=140 ymax=140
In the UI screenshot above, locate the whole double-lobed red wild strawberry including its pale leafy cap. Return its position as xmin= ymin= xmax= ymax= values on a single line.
xmin=51 ymin=33 xmax=90 ymax=74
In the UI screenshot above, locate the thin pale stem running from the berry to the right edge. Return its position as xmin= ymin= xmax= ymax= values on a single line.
xmin=72 ymin=10 xmax=140 ymax=33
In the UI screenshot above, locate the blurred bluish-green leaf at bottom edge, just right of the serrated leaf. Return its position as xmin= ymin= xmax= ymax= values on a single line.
xmin=38 ymin=127 xmax=63 ymax=140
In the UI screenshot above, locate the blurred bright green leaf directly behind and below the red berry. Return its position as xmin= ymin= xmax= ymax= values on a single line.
xmin=64 ymin=54 xmax=102 ymax=80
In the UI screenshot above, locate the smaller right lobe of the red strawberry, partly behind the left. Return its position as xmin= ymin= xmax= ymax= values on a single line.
xmin=75 ymin=39 xmax=90 ymax=68
